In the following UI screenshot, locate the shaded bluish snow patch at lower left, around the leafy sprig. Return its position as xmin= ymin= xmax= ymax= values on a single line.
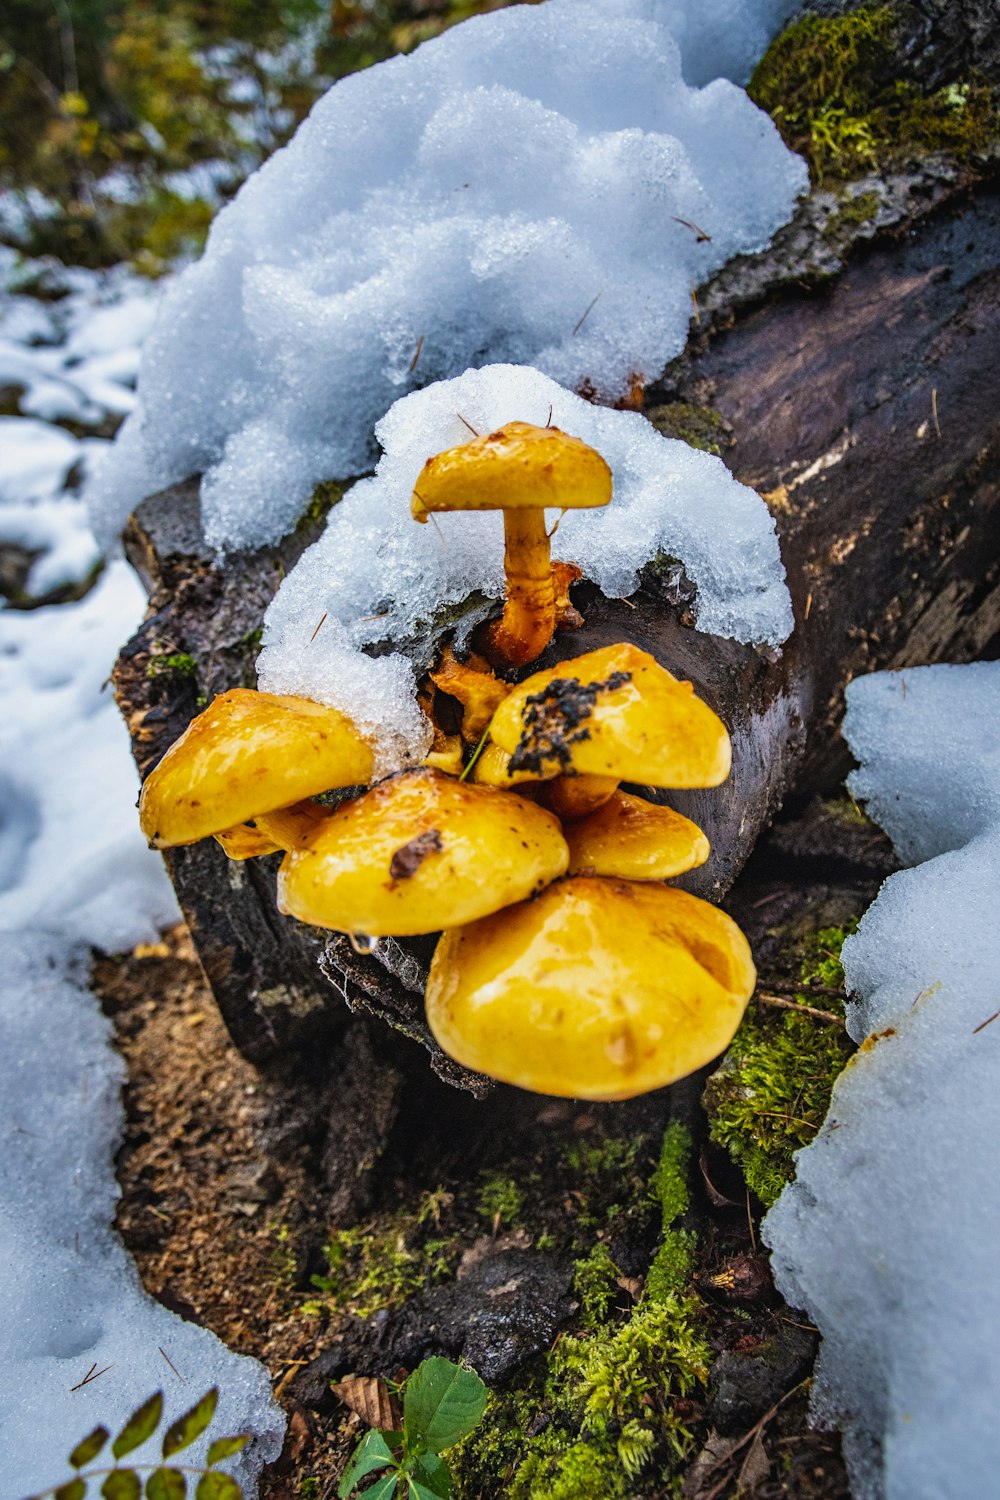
xmin=0 ymin=933 xmax=283 ymax=1500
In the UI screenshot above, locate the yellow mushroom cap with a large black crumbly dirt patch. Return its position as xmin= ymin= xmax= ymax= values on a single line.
xmin=490 ymin=642 xmax=732 ymax=788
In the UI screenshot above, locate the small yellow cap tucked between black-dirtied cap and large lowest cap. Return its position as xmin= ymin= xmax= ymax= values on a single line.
xmin=564 ymin=783 xmax=711 ymax=881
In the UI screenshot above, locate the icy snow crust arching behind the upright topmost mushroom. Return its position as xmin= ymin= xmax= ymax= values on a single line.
xmin=258 ymin=365 xmax=792 ymax=770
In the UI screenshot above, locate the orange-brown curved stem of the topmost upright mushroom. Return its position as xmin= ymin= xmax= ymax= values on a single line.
xmin=489 ymin=510 xmax=556 ymax=666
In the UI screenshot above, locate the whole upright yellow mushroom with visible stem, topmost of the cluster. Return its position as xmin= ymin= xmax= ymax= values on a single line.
xmin=411 ymin=422 xmax=612 ymax=666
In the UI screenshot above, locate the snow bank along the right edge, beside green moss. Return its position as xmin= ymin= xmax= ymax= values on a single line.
xmin=765 ymin=662 xmax=1000 ymax=1500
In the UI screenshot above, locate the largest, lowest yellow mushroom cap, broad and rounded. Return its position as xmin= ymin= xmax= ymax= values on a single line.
xmin=427 ymin=876 xmax=756 ymax=1100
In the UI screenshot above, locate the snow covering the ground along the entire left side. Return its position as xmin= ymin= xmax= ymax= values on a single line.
xmin=0 ymin=261 xmax=283 ymax=1500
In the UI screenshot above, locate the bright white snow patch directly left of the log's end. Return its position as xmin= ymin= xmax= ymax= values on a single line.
xmin=0 ymin=563 xmax=177 ymax=953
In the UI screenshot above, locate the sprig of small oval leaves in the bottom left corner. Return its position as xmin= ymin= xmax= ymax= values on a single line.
xmin=23 ymin=1386 xmax=250 ymax=1500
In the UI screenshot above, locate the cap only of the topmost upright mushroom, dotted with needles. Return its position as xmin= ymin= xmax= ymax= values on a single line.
xmin=409 ymin=422 xmax=612 ymax=521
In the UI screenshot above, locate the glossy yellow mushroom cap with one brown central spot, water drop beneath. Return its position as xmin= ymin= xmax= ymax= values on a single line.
xmin=277 ymin=768 xmax=570 ymax=938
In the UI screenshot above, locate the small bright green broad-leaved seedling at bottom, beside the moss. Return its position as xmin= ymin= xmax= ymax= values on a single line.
xmin=340 ymin=1358 xmax=486 ymax=1500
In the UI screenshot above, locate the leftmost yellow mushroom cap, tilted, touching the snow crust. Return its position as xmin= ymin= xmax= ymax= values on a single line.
xmin=139 ymin=687 xmax=373 ymax=849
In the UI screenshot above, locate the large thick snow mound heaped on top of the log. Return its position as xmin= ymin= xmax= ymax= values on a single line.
xmin=91 ymin=0 xmax=807 ymax=551
